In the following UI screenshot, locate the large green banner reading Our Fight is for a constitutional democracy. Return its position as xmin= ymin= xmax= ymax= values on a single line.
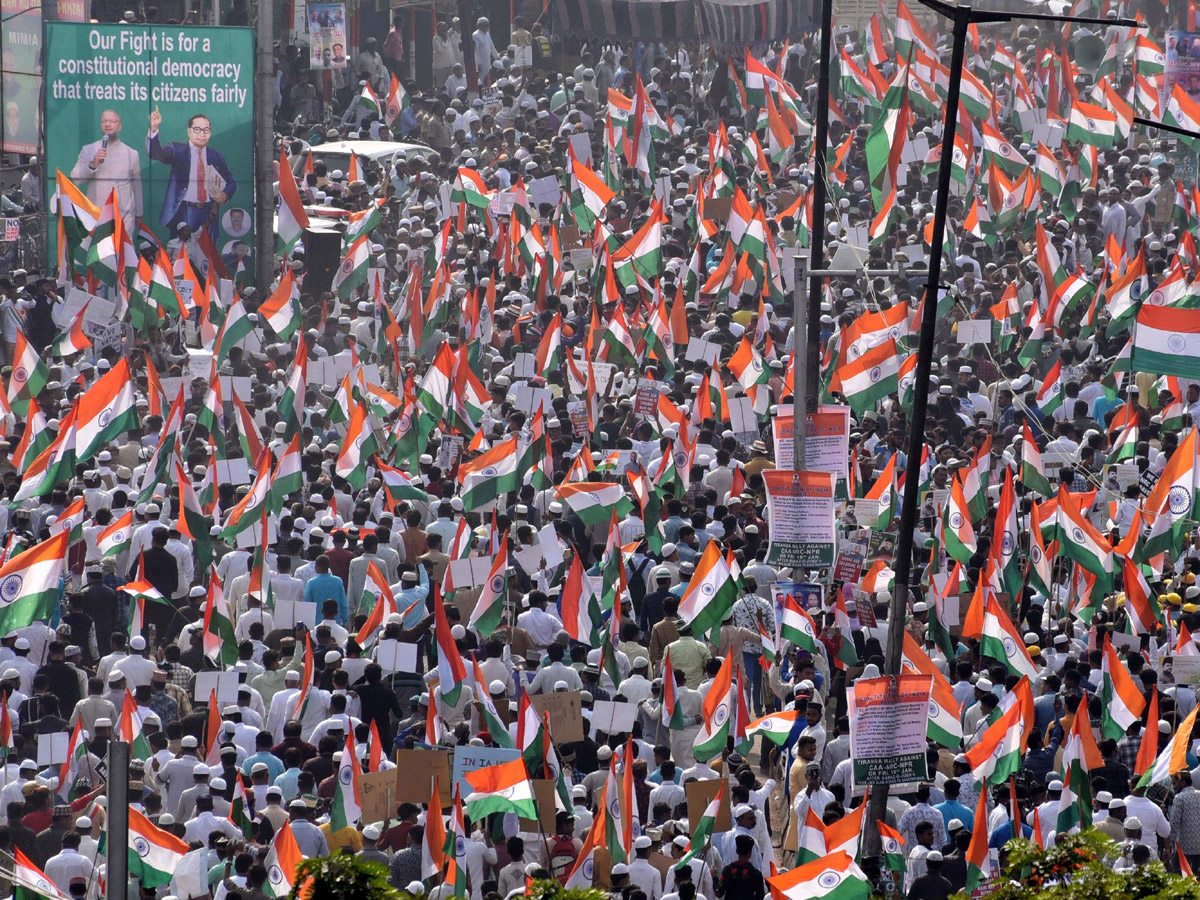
xmin=43 ymin=22 xmax=254 ymax=276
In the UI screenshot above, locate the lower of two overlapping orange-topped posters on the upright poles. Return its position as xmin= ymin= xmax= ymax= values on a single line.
xmin=762 ymin=469 xmax=836 ymax=569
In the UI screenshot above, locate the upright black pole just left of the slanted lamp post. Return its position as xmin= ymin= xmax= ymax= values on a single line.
xmin=796 ymin=0 xmax=833 ymax=417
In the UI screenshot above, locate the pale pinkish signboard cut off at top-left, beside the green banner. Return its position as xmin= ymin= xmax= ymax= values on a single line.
xmin=0 ymin=0 xmax=41 ymax=153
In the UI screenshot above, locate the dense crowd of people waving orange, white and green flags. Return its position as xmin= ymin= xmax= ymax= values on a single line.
xmin=0 ymin=2 xmax=1200 ymax=900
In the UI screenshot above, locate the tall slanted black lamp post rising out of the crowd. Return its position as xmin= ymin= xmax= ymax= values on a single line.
xmin=865 ymin=0 xmax=972 ymax=856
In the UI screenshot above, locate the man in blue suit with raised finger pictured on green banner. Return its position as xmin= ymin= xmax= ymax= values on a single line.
xmin=146 ymin=107 xmax=238 ymax=239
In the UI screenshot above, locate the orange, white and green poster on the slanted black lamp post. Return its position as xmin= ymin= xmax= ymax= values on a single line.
xmin=850 ymin=674 xmax=934 ymax=786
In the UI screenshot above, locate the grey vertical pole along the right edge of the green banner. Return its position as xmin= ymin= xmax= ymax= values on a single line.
xmin=254 ymin=0 xmax=275 ymax=292
